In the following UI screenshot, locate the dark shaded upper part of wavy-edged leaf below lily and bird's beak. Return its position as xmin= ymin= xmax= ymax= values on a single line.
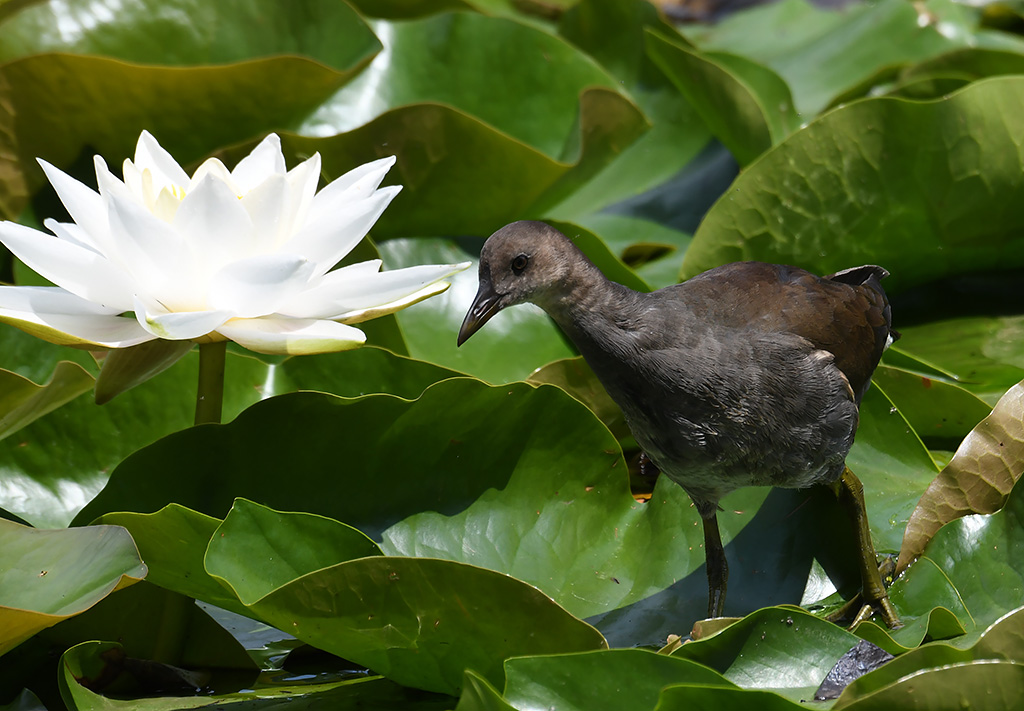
xmin=77 ymin=378 xmax=622 ymax=536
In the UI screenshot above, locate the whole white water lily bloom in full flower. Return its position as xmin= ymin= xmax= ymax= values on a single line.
xmin=0 ymin=131 xmax=469 ymax=354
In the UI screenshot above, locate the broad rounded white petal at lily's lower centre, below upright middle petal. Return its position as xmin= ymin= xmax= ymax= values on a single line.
xmin=209 ymin=254 xmax=313 ymax=319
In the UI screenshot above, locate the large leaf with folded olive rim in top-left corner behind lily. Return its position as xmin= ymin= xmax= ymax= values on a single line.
xmin=0 ymin=0 xmax=380 ymax=216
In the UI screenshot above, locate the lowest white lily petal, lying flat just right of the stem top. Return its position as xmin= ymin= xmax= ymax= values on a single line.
xmin=217 ymin=317 xmax=367 ymax=356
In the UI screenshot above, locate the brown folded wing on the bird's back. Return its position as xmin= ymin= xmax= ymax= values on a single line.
xmin=670 ymin=261 xmax=892 ymax=404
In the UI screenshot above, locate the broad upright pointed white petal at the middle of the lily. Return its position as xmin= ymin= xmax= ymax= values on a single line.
xmin=172 ymin=175 xmax=254 ymax=275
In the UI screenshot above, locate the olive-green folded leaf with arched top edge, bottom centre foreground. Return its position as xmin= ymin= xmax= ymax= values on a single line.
xmin=217 ymin=555 xmax=606 ymax=694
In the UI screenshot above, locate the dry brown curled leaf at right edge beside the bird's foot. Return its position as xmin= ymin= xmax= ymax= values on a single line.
xmin=896 ymin=383 xmax=1024 ymax=574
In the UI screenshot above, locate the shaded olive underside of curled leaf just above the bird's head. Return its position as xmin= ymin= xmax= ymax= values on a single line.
xmin=276 ymin=93 xmax=646 ymax=239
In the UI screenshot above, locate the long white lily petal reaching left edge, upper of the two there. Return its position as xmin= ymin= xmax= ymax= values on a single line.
xmin=0 ymin=222 xmax=132 ymax=311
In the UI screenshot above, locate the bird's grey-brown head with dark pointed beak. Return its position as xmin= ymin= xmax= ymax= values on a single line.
xmin=459 ymin=220 xmax=589 ymax=345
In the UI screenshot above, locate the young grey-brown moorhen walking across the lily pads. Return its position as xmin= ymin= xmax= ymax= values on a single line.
xmin=457 ymin=220 xmax=900 ymax=628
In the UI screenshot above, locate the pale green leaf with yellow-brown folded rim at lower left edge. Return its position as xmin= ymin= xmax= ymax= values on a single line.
xmin=0 ymin=519 xmax=145 ymax=654
